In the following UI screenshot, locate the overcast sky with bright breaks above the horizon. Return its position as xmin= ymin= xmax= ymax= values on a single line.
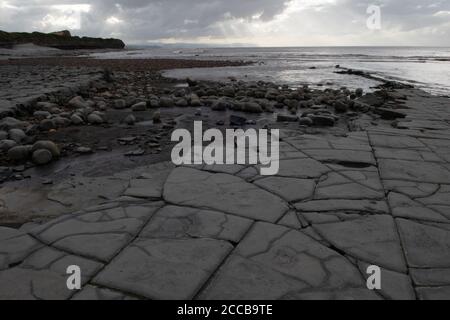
xmin=0 ymin=0 xmax=450 ymax=46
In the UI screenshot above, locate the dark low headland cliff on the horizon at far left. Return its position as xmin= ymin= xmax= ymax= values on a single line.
xmin=0 ymin=30 xmax=125 ymax=50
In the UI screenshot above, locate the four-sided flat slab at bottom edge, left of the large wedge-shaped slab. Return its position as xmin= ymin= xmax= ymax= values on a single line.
xmin=94 ymin=239 xmax=233 ymax=300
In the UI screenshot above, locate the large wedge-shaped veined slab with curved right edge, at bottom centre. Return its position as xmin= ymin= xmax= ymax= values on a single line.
xmin=200 ymin=223 xmax=378 ymax=300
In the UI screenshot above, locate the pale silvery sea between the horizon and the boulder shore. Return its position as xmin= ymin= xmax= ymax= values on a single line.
xmin=92 ymin=46 xmax=450 ymax=96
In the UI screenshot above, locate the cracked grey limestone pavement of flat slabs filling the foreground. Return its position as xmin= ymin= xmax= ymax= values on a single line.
xmin=0 ymin=86 xmax=450 ymax=299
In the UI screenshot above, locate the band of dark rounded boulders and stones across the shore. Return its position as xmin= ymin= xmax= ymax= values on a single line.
xmin=0 ymin=58 xmax=414 ymax=177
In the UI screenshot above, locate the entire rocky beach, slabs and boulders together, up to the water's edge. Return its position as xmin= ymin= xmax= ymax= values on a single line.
xmin=0 ymin=53 xmax=450 ymax=300
